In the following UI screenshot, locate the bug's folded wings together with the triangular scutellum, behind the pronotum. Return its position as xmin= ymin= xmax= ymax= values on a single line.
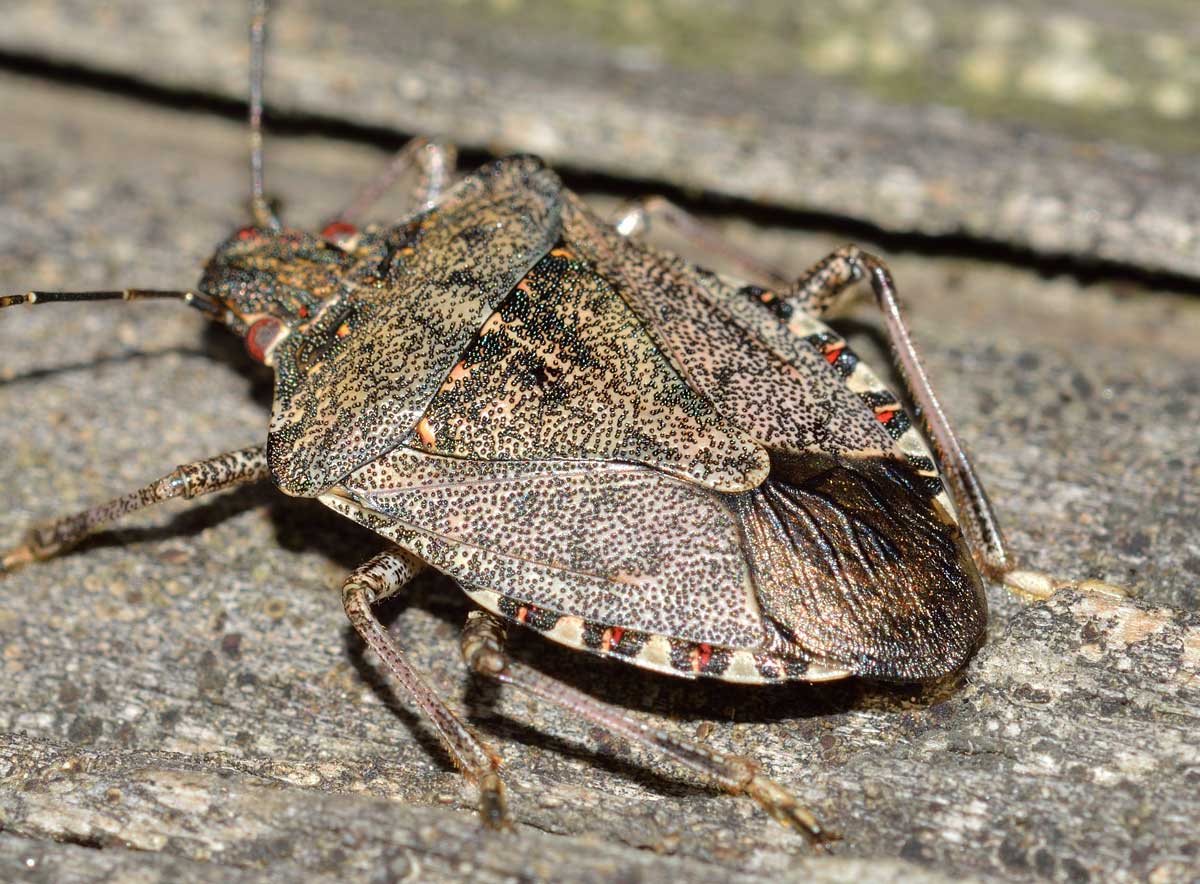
xmin=322 ymin=161 xmax=985 ymax=679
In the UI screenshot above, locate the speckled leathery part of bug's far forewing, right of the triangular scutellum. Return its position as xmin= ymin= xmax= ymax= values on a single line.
xmin=563 ymin=193 xmax=894 ymax=455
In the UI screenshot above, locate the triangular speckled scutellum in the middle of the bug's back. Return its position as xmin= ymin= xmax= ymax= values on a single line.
xmin=410 ymin=248 xmax=770 ymax=492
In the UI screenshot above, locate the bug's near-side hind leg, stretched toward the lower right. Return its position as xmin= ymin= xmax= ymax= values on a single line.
xmin=462 ymin=611 xmax=836 ymax=843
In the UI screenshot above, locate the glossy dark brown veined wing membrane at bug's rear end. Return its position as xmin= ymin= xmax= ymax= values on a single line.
xmin=733 ymin=455 xmax=986 ymax=680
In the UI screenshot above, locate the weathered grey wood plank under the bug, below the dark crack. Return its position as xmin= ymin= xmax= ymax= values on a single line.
xmin=0 ymin=5 xmax=1200 ymax=882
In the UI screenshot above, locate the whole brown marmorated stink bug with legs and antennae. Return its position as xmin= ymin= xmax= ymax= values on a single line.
xmin=0 ymin=0 xmax=1123 ymax=840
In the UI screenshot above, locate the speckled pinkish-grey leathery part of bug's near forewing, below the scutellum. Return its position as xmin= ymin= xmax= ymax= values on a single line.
xmin=333 ymin=449 xmax=763 ymax=648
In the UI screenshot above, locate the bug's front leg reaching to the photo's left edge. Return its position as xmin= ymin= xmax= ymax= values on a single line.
xmin=0 ymin=445 xmax=270 ymax=573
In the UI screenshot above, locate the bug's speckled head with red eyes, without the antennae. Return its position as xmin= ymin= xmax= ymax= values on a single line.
xmin=199 ymin=225 xmax=361 ymax=363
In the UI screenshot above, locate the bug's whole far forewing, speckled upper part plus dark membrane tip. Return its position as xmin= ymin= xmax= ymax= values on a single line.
xmin=563 ymin=194 xmax=986 ymax=679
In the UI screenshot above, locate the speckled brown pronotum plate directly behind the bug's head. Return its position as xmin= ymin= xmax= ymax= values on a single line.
xmin=268 ymin=157 xmax=562 ymax=495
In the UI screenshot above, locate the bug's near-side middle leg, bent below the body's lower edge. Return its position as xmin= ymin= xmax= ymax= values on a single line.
xmin=342 ymin=547 xmax=510 ymax=829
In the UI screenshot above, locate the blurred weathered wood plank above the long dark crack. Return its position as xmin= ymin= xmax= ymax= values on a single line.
xmin=0 ymin=0 xmax=1200 ymax=276
